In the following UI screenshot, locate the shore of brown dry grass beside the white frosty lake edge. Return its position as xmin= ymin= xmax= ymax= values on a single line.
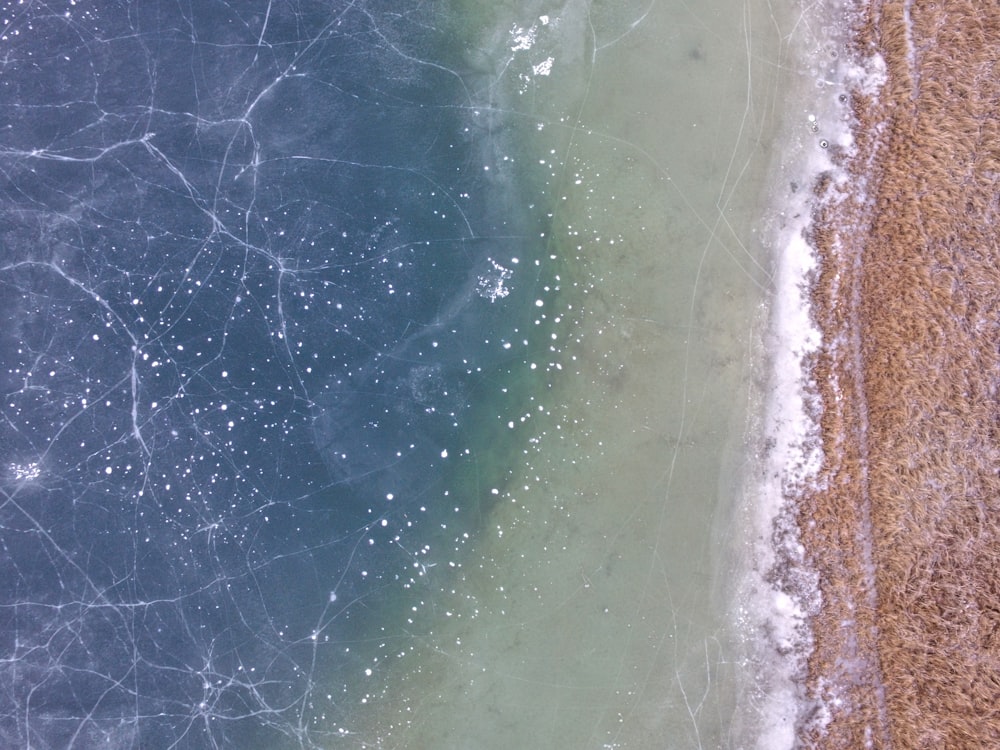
xmin=798 ymin=0 xmax=1000 ymax=749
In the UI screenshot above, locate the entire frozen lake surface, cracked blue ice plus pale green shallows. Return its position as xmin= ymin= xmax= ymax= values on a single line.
xmin=0 ymin=0 xmax=820 ymax=750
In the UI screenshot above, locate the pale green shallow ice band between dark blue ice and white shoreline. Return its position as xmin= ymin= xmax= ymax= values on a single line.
xmin=338 ymin=0 xmax=804 ymax=750
